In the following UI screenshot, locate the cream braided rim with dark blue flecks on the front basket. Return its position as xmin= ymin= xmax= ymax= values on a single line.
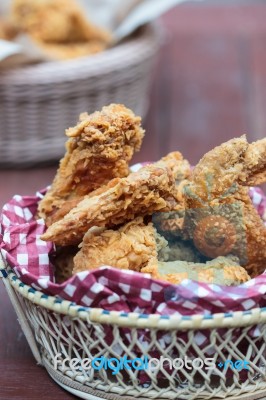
xmin=0 ymin=256 xmax=266 ymax=331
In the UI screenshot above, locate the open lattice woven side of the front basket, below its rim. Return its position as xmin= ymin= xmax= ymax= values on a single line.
xmin=26 ymin=301 xmax=266 ymax=400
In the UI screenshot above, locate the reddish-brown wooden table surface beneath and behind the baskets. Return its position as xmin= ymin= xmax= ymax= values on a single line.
xmin=0 ymin=1 xmax=266 ymax=400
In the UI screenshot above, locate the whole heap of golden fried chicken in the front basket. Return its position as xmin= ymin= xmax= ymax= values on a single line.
xmin=39 ymin=105 xmax=266 ymax=286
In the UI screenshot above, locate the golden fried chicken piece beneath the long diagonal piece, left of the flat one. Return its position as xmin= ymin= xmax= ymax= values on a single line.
xmin=73 ymin=217 xmax=167 ymax=273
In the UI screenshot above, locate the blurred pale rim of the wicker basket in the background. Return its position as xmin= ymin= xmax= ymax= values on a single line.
xmin=0 ymin=22 xmax=163 ymax=86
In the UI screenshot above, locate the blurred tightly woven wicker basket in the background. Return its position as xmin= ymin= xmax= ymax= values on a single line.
xmin=0 ymin=24 xmax=161 ymax=165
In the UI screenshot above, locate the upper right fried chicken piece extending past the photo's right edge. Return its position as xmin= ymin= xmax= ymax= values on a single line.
xmin=186 ymin=136 xmax=266 ymax=205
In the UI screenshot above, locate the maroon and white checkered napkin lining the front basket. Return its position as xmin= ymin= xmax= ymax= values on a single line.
xmin=0 ymin=188 xmax=266 ymax=315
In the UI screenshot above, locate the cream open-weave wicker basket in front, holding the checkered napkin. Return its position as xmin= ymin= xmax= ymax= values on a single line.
xmin=0 ymin=253 xmax=266 ymax=400
